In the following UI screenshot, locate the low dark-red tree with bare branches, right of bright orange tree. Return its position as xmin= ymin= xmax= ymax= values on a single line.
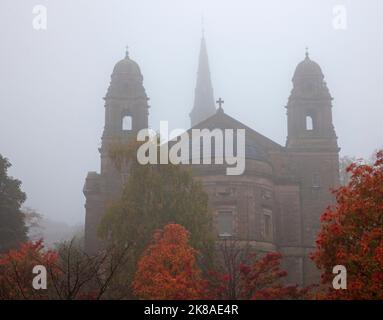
xmin=209 ymin=239 xmax=313 ymax=300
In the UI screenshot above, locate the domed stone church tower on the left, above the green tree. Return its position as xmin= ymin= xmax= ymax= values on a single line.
xmin=84 ymin=51 xmax=149 ymax=253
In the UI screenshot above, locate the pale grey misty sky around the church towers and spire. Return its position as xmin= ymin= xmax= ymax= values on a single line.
xmin=0 ymin=0 xmax=383 ymax=224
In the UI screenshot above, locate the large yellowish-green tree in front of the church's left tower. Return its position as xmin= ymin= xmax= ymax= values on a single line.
xmin=100 ymin=143 xmax=214 ymax=286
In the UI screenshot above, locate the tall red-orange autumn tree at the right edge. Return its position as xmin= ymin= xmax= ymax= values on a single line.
xmin=312 ymin=151 xmax=383 ymax=299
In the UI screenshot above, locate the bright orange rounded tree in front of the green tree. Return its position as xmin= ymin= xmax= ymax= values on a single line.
xmin=133 ymin=224 xmax=206 ymax=300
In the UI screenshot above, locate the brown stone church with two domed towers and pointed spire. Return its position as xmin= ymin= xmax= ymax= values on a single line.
xmin=84 ymin=37 xmax=339 ymax=285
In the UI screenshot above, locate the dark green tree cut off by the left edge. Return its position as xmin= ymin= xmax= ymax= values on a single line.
xmin=0 ymin=155 xmax=27 ymax=252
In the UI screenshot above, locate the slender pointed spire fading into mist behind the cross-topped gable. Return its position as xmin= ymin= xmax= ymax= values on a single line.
xmin=190 ymin=33 xmax=216 ymax=127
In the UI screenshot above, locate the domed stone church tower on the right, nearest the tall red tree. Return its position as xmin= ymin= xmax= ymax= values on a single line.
xmin=286 ymin=52 xmax=339 ymax=283
